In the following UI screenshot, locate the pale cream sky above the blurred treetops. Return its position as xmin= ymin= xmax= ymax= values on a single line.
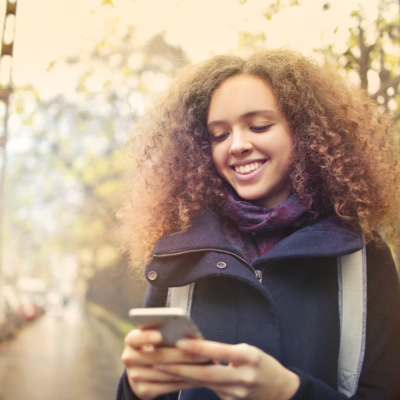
xmin=0 ymin=0 xmax=388 ymax=95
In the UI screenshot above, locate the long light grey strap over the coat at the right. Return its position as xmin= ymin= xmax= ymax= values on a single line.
xmin=338 ymin=245 xmax=367 ymax=397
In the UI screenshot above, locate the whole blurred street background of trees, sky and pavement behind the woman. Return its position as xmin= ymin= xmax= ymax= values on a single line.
xmin=0 ymin=0 xmax=400 ymax=400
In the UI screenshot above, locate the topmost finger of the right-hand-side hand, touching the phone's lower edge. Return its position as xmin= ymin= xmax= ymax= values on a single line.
xmin=176 ymin=339 xmax=262 ymax=365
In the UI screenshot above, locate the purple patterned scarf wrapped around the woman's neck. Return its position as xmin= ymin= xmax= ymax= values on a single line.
xmin=221 ymin=188 xmax=308 ymax=262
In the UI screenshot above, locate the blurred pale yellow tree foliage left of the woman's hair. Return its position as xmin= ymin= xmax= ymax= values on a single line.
xmin=5 ymin=22 xmax=188 ymax=290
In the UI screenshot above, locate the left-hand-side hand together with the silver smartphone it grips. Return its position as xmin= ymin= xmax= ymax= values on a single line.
xmin=122 ymin=308 xmax=208 ymax=399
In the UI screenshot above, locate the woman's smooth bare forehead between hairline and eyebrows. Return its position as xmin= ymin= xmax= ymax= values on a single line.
xmin=207 ymin=75 xmax=279 ymax=122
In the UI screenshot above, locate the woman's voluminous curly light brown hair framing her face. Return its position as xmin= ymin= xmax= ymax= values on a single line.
xmin=119 ymin=49 xmax=399 ymax=266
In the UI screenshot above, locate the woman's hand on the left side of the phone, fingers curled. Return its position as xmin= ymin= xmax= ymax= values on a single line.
xmin=121 ymin=329 xmax=208 ymax=400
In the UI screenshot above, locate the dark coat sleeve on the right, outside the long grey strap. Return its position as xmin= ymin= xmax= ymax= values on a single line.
xmin=291 ymin=241 xmax=400 ymax=400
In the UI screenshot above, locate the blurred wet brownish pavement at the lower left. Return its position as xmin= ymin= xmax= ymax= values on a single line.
xmin=0 ymin=303 xmax=123 ymax=400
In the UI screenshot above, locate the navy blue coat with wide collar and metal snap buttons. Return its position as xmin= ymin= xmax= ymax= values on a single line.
xmin=117 ymin=212 xmax=400 ymax=400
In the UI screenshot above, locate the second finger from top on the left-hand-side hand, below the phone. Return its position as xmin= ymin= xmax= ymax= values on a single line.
xmin=121 ymin=346 xmax=209 ymax=366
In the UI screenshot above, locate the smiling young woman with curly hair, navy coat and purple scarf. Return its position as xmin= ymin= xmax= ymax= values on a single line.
xmin=117 ymin=50 xmax=400 ymax=400
